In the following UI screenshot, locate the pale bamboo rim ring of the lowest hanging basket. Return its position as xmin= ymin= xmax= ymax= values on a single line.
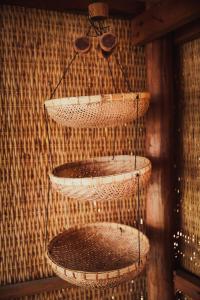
xmin=45 ymin=222 xmax=150 ymax=280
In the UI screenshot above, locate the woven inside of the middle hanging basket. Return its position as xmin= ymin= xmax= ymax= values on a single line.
xmin=53 ymin=155 xmax=149 ymax=178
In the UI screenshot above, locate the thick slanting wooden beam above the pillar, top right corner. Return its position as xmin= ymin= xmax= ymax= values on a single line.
xmin=132 ymin=0 xmax=200 ymax=45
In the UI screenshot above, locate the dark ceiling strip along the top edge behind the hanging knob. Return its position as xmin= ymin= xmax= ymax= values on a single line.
xmin=1 ymin=0 xmax=145 ymax=17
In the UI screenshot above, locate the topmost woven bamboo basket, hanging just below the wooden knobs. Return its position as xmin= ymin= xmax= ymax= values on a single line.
xmin=45 ymin=92 xmax=150 ymax=128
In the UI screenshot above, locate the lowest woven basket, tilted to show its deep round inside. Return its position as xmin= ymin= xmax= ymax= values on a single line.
xmin=46 ymin=222 xmax=149 ymax=288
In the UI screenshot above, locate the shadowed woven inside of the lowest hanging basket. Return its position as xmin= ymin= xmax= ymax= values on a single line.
xmin=48 ymin=223 xmax=148 ymax=272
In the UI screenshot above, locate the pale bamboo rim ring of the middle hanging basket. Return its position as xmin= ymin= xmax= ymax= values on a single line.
xmin=49 ymin=155 xmax=152 ymax=186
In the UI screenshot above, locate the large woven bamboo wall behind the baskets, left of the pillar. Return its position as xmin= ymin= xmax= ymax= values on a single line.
xmin=0 ymin=6 xmax=146 ymax=299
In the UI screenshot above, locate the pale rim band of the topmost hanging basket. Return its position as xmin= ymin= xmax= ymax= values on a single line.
xmin=45 ymin=92 xmax=150 ymax=108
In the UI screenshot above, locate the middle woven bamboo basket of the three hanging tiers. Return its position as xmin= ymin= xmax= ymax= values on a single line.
xmin=50 ymin=155 xmax=151 ymax=201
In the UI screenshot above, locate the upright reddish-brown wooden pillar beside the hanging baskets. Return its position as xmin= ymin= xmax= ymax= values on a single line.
xmin=146 ymin=36 xmax=174 ymax=300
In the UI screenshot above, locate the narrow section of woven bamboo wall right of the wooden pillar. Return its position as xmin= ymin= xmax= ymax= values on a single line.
xmin=175 ymin=39 xmax=200 ymax=276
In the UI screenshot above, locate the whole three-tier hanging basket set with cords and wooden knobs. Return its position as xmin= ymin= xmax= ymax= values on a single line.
xmin=45 ymin=3 xmax=151 ymax=288
